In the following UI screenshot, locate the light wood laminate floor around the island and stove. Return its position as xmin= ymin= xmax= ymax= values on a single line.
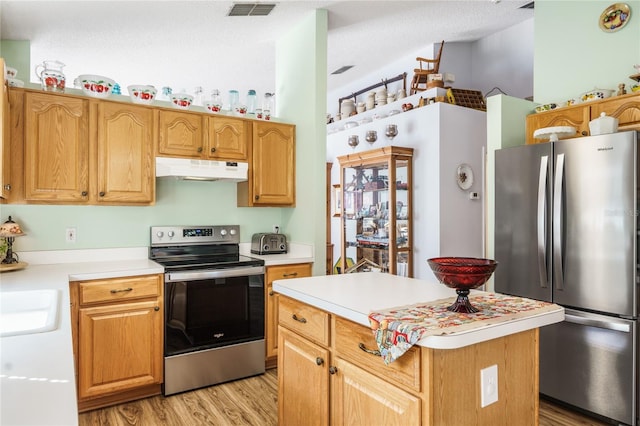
xmin=79 ymin=369 xmax=606 ymax=426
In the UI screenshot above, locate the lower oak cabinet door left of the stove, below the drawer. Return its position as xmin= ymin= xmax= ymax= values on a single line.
xmin=77 ymin=300 xmax=163 ymax=398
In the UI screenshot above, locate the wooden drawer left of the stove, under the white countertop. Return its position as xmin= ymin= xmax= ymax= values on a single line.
xmin=79 ymin=275 xmax=162 ymax=305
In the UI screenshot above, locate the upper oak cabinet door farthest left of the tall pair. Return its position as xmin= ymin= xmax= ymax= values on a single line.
xmin=24 ymin=93 xmax=89 ymax=204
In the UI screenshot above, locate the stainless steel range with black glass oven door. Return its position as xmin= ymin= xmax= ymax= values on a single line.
xmin=149 ymin=225 xmax=265 ymax=395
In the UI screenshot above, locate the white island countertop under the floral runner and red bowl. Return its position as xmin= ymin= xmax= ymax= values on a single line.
xmin=273 ymin=272 xmax=564 ymax=349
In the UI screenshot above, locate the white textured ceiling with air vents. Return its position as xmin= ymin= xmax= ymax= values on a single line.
xmin=0 ymin=0 xmax=533 ymax=96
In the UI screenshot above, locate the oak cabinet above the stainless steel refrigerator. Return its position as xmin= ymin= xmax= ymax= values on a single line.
xmin=525 ymin=93 xmax=640 ymax=144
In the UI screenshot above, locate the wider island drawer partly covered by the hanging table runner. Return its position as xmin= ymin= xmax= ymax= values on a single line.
xmin=334 ymin=318 xmax=420 ymax=392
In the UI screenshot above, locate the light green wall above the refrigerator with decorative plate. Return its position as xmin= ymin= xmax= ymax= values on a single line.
xmin=533 ymin=0 xmax=640 ymax=103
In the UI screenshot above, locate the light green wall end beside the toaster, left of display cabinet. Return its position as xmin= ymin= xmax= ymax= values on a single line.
xmin=276 ymin=10 xmax=328 ymax=275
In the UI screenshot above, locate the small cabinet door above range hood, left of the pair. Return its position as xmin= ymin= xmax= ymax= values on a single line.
xmin=158 ymin=111 xmax=203 ymax=158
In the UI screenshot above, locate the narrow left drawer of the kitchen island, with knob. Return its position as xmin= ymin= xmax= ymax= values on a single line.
xmin=278 ymin=296 xmax=329 ymax=346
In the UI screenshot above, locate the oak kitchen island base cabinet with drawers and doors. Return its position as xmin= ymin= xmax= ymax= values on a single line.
xmin=278 ymin=295 xmax=538 ymax=426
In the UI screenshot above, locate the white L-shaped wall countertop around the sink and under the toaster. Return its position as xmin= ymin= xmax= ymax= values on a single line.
xmin=0 ymin=243 xmax=313 ymax=426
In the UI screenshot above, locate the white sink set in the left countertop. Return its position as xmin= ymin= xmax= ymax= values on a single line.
xmin=0 ymin=290 xmax=59 ymax=337
